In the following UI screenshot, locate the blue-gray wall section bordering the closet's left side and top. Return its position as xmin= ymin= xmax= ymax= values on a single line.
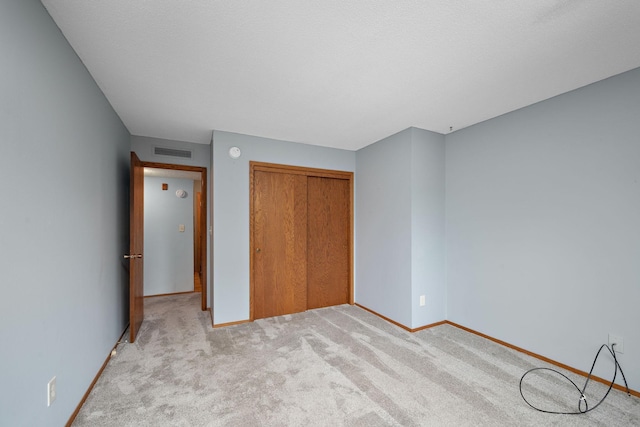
xmin=212 ymin=131 xmax=355 ymax=324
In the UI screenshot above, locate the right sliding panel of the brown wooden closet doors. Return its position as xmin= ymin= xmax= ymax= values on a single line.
xmin=307 ymin=176 xmax=351 ymax=308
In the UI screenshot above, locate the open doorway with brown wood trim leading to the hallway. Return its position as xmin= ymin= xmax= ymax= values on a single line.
xmin=142 ymin=162 xmax=207 ymax=310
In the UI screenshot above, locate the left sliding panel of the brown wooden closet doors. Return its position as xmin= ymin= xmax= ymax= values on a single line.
xmin=252 ymin=171 xmax=307 ymax=319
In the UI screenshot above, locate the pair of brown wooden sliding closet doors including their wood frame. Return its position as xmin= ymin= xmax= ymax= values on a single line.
xmin=249 ymin=162 xmax=354 ymax=320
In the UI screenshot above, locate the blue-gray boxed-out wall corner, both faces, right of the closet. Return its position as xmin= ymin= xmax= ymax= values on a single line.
xmin=356 ymin=128 xmax=446 ymax=328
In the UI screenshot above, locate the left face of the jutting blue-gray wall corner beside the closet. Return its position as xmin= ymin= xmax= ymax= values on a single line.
xmin=355 ymin=129 xmax=412 ymax=327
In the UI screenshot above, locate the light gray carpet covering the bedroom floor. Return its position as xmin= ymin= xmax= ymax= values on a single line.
xmin=74 ymin=294 xmax=640 ymax=426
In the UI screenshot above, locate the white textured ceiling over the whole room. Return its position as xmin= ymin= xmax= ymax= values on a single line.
xmin=42 ymin=0 xmax=640 ymax=150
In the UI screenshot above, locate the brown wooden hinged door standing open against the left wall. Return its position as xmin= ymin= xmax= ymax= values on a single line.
xmin=128 ymin=152 xmax=144 ymax=342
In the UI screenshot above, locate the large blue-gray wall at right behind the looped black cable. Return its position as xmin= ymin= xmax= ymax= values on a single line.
xmin=446 ymin=69 xmax=640 ymax=390
